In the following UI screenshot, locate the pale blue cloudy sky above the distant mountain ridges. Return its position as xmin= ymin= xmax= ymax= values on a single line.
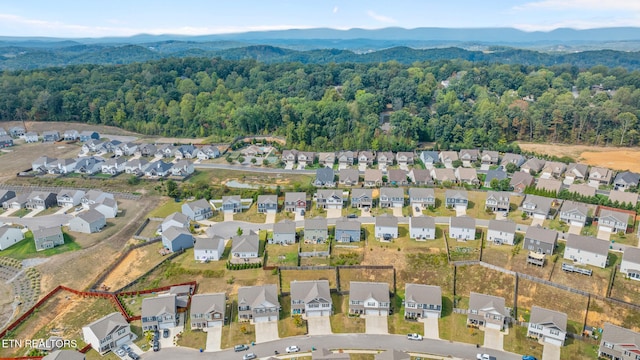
xmin=0 ymin=0 xmax=640 ymax=37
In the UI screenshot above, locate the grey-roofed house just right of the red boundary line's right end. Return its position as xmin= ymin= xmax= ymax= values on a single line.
xmin=189 ymin=293 xmax=227 ymax=330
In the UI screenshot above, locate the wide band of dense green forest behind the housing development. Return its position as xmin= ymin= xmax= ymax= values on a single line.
xmin=0 ymin=58 xmax=640 ymax=151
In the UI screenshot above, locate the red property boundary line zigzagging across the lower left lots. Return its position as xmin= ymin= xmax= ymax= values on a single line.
xmin=0 ymin=281 xmax=198 ymax=360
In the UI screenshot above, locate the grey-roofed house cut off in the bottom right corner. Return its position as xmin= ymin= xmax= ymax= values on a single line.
xmin=598 ymin=322 xmax=640 ymax=360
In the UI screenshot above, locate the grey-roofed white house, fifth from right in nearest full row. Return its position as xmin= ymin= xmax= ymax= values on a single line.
xmin=349 ymin=281 xmax=391 ymax=316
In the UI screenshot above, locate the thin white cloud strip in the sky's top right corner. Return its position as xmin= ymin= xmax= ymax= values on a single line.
xmin=513 ymin=0 xmax=640 ymax=11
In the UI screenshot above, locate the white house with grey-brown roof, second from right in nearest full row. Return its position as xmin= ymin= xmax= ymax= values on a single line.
xmin=527 ymin=305 xmax=567 ymax=346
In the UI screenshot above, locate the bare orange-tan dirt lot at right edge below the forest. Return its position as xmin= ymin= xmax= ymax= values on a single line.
xmin=518 ymin=143 xmax=640 ymax=171
